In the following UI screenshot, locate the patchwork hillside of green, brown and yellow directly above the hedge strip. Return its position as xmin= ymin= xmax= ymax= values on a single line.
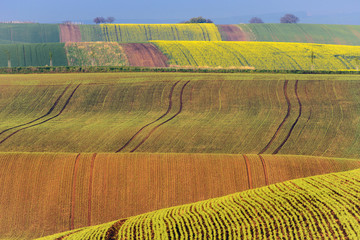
xmin=0 ymin=41 xmax=360 ymax=71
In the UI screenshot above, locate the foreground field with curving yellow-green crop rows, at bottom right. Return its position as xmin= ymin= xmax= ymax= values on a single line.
xmin=35 ymin=169 xmax=360 ymax=240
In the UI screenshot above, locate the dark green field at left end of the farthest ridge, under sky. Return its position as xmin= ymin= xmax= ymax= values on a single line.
xmin=0 ymin=23 xmax=60 ymax=44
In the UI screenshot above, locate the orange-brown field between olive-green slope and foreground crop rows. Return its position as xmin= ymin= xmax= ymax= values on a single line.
xmin=0 ymin=153 xmax=360 ymax=239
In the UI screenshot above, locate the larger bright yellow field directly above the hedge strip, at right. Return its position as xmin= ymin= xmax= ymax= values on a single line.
xmin=153 ymin=41 xmax=360 ymax=70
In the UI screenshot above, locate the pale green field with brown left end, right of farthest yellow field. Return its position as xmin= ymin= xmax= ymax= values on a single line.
xmin=218 ymin=23 xmax=360 ymax=45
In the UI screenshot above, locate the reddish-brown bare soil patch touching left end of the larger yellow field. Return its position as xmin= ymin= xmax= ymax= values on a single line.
xmin=121 ymin=43 xmax=168 ymax=67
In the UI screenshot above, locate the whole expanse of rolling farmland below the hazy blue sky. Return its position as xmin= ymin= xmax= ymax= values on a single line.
xmin=0 ymin=20 xmax=360 ymax=240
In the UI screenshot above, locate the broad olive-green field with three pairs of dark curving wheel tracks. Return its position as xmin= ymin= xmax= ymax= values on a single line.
xmin=0 ymin=73 xmax=360 ymax=158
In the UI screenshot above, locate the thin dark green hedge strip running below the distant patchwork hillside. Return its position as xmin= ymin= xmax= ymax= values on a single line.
xmin=0 ymin=66 xmax=360 ymax=74
